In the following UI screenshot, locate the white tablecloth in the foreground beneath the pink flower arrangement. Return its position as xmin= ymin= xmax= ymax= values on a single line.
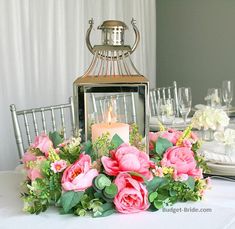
xmin=0 ymin=171 xmax=235 ymax=229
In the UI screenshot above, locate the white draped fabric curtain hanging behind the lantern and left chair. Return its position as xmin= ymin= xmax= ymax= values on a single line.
xmin=0 ymin=0 xmax=156 ymax=170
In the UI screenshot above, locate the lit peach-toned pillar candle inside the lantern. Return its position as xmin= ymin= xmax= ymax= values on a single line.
xmin=91 ymin=122 xmax=129 ymax=143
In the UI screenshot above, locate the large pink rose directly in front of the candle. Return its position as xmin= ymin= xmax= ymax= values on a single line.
xmin=101 ymin=144 xmax=152 ymax=179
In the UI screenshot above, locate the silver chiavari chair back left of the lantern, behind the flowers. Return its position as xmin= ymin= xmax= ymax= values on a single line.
xmin=10 ymin=97 xmax=76 ymax=158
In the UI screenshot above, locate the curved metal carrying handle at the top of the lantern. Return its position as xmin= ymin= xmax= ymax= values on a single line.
xmin=86 ymin=18 xmax=140 ymax=59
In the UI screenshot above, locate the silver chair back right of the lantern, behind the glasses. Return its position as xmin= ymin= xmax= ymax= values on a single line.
xmin=149 ymin=81 xmax=179 ymax=117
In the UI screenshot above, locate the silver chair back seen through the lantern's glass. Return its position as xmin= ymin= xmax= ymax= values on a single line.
xmin=91 ymin=92 xmax=137 ymax=124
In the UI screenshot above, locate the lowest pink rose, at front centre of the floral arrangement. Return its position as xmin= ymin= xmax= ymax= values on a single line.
xmin=114 ymin=173 xmax=149 ymax=213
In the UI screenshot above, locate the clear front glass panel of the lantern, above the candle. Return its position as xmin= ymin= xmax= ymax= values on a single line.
xmin=75 ymin=84 xmax=148 ymax=151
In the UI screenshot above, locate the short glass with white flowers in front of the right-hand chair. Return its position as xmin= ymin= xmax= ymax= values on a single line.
xmin=157 ymin=98 xmax=176 ymax=125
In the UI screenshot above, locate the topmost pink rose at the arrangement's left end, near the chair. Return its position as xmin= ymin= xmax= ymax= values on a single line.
xmin=31 ymin=133 xmax=53 ymax=156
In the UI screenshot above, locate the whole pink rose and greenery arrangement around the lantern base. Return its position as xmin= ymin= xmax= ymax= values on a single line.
xmin=22 ymin=127 xmax=209 ymax=217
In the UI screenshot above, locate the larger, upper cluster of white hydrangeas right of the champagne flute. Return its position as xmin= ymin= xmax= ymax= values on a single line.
xmin=192 ymin=107 xmax=229 ymax=130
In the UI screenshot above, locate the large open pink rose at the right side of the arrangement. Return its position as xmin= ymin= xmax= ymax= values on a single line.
xmin=161 ymin=146 xmax=202 ymax=180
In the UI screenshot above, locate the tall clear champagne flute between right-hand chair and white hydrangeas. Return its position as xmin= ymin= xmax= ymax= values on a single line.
xmin=178 ymin=87 xmax=192 ymax=125
